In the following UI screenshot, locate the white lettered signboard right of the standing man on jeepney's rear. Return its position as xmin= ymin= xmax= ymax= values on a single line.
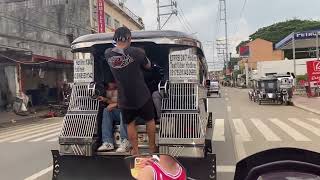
xmin=169 ymin=51 xmax=199 ymax=83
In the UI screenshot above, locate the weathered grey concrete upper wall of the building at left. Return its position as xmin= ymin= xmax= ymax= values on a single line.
xmin=0 ymin=0 xmax=90 ymax=59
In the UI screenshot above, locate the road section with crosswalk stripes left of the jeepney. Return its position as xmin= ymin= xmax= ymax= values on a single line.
xmin=0 ymin=118 xmax=62 ymax=180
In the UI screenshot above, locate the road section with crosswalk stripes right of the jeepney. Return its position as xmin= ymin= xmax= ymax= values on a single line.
xmin=209 ymin=88 xmax=320 ymax=179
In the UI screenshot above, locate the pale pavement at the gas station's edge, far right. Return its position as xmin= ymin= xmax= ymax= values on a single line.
xmin=292 ymin=96 xmax=320 ymax=115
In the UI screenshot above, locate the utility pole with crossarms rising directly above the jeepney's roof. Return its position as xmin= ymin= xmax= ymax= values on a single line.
xmin=157 ymin=0 xmax=178 ymax=30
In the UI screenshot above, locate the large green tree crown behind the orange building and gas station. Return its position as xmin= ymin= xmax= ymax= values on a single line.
xmin=236 ymin=19 xmax=320 ymax=52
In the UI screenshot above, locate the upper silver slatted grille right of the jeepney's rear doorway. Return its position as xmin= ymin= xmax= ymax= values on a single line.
xmin=161 ymin=83 xmax=199 ymax=110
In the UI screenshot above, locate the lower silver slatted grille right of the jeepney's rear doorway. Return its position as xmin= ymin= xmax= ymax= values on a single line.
xmin=159 ymin=113 xmax=206 ymax=140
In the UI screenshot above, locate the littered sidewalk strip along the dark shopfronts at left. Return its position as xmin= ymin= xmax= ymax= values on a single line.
xmin=0 ymin=110 xmax=48 ymax=124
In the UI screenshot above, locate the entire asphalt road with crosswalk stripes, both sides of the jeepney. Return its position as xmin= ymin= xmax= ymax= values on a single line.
xmin=0 ymin=88 xmax=320 ymax=180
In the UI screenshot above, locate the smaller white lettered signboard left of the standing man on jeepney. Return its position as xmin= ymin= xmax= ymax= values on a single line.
xmin=73 ymin=59 xmax=94 ymax=83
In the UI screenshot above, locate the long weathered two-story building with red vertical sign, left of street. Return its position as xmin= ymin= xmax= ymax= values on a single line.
xmin=0 ymin=0 xmax=144 ymax=108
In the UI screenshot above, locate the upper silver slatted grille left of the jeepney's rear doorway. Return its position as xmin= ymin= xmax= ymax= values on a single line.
xmin=68 ymin=84 xmax=99 ymax=112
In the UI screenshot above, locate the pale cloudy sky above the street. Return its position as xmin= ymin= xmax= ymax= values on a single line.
xmin=126 ymin=0 xmax=320 ymax=68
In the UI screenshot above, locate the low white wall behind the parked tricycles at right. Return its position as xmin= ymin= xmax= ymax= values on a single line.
xmin=257 ymin=59 xmax=314 ymax=77
